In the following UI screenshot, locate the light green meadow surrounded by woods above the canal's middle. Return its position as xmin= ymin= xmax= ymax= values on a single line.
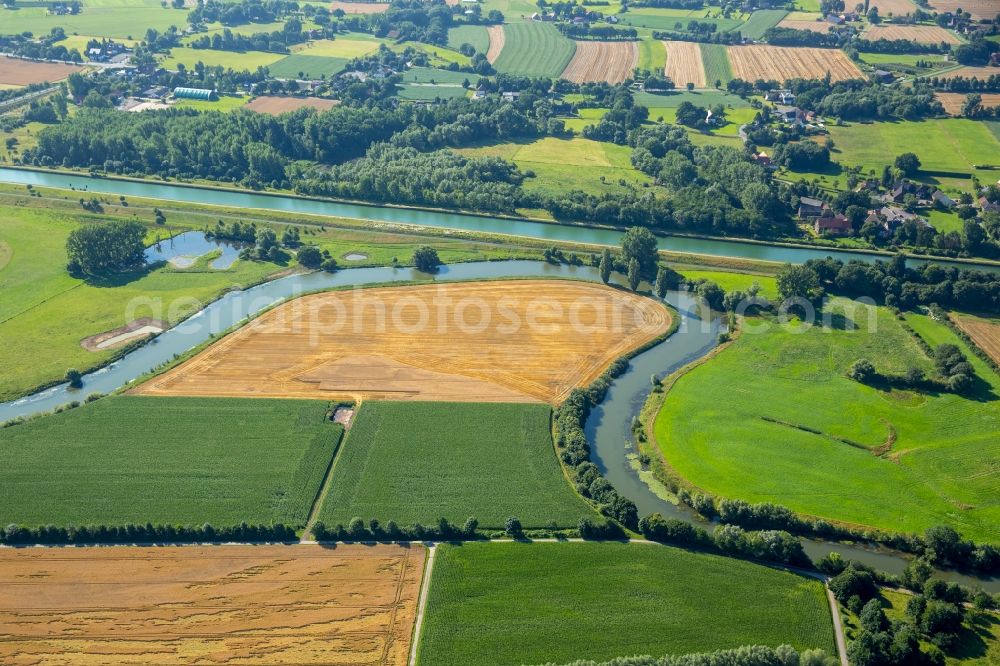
xmin=457 ymin=136 xmax=652 ymax=194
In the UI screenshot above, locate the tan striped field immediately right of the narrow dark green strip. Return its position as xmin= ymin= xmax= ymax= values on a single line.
xmin=726 ymin=44 xmax=864 ymax=82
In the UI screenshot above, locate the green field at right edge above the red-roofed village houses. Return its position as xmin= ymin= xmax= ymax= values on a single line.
xmin=829 ymin=118 xmax=1000 ymax=188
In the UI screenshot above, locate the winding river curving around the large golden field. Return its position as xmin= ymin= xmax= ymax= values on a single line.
xmin=0 ymin=261 xmax=1000 ymax=591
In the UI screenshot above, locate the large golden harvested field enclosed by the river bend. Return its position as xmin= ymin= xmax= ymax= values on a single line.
xmin=135 ymin=280 xmax=670 ymax=404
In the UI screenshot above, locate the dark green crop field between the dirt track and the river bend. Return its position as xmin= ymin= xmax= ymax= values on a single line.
xmin=320 ymin=402 xmax=593 ymax=528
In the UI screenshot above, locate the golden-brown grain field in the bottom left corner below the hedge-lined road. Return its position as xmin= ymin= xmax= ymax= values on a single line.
xmin=0 ymin=545 xmax=426 ymax=666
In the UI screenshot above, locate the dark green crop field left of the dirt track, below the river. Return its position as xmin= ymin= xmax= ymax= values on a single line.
xmin=0 ymin=396 xmax=342 ymax=526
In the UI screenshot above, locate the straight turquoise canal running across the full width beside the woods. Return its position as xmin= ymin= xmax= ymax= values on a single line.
xmin=0 ymin=167 xmax=1000 ymax=273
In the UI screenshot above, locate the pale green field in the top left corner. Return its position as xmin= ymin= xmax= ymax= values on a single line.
xmin=0 ymin=0 xmax=187 ymax=39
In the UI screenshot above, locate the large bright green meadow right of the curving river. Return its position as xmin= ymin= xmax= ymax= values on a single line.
xmin=655 ymin=300 xmax=1000 ymax=543
